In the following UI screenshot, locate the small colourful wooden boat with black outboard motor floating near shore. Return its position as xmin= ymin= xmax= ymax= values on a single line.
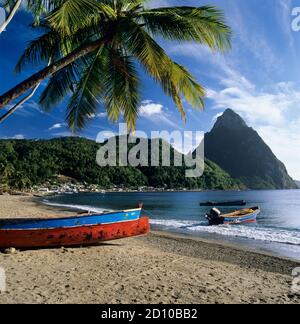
xmin=206 ymin=207 xmax=260 ymax=225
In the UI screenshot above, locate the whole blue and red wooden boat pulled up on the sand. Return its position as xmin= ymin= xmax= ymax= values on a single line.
xmin=0 ymin=208 xmax=150 ymax=249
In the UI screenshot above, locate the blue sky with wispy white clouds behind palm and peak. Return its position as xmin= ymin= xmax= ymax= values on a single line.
xmin=0 ymin=0 xmax=300 ymax=180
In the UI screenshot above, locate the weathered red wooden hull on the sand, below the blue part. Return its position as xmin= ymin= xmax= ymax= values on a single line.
xmin=0 ymin=217 xmax=150 ymax=248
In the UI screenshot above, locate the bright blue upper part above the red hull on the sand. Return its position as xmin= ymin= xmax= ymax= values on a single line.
xmin=0 ymin=208 xmax=142 ymax=230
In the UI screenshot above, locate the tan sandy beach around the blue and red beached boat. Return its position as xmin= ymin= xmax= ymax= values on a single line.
xmin=0 ymin=196 xmax=300 ymax=304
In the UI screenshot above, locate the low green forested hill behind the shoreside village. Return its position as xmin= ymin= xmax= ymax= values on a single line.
xmin=0 ymin=137 xmax=239 ymax=191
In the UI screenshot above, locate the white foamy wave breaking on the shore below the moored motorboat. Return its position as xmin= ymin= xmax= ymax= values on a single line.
xmin=151 ymin=219 xmax=300 ymax=246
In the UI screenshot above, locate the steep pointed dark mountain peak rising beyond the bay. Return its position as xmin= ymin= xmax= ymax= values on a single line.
xmin=205 ymin=109 xmax=297 ymax=189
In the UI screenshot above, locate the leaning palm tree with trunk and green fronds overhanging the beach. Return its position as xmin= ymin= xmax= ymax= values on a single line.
xmin=0 ymin=0 xmax=231 ymax=131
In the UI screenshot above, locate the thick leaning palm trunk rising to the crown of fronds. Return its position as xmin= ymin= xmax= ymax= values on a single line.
xmin=0 ymin=38 xmax=109 ymax=109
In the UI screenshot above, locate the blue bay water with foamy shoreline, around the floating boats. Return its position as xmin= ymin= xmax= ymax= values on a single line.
xmin=44 ymin=190 xmax=300 ymax=260
